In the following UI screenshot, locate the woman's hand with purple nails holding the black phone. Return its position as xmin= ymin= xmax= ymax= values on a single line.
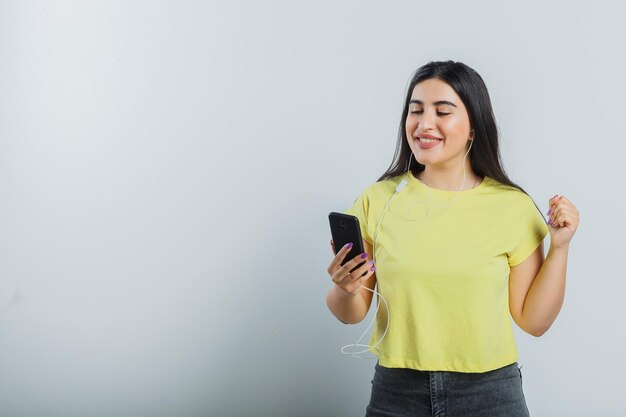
xmin=328 ymin=240 xmax=376 ymax=296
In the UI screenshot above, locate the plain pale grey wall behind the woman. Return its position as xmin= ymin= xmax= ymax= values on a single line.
xmin=0 ymin=0 xmax=626 ymax=417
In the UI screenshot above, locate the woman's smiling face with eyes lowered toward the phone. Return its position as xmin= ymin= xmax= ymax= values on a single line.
xmin=405 ymin=78 xmax=471 ymax=169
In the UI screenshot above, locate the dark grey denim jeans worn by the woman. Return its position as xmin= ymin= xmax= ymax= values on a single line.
xmin=365 ymin=362 xmax=529 ymax=417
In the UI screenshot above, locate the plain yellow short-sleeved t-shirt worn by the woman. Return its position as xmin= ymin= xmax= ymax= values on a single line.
xmin=346 ymin=174 xmax=548 ymax=372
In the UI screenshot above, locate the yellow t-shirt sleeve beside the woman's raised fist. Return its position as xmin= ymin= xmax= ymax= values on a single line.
xmin=508 ymin=196 xmax=548 ymax=266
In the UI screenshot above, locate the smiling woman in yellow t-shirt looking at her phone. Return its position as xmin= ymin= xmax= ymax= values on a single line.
xmin=326 ymin=61 xmax=578 ymax=417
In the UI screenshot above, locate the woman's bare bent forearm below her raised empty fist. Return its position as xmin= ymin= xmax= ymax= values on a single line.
xmin=522 ymin=246 xmax=569 ymax=336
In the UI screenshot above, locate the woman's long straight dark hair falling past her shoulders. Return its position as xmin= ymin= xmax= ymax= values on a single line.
xmin=377 ymin=61 xmax=545 ymax=220
